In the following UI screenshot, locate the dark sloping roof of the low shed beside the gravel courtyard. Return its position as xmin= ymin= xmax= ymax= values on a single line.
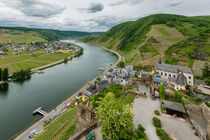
xmin=163 ymin=100 xmax=186 ymax=113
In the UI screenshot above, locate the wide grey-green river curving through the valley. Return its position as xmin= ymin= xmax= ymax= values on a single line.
xmin=0 ymin=43 xmax=117 ymax=140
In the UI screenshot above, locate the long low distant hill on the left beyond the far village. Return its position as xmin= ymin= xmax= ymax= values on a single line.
xmin=0 ymin=27 xmax=100 ymax=43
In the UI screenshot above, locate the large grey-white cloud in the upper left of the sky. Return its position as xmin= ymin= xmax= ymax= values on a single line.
xmin=2 ymin=0 xmax=65 ymax=18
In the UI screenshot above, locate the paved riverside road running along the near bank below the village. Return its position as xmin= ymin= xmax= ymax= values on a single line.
xmin=15 ymin=43 xmax=122 ymax=140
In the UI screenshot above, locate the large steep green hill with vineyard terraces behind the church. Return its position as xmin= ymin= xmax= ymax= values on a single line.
xmin=82 ymin=14 xmax=210 ymax=74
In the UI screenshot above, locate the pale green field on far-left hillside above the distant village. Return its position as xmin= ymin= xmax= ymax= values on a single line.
xmin=0 ymin=29 xmax=45 ymax=44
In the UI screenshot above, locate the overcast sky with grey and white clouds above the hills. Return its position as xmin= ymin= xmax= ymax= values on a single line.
xmin=0 ymin=0 xmax=210 ymax=31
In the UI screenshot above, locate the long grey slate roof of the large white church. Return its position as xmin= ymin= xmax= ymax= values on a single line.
xmin=156 ymin=64 xmax=193 ymax=74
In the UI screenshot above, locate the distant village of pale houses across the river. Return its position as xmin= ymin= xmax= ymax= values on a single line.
xmin=0 ymin=41 xmax=80 ymax=55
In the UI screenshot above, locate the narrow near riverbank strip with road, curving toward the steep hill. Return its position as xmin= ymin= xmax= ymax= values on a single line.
xmin=15 ymin=41 xmax=122 ymax=140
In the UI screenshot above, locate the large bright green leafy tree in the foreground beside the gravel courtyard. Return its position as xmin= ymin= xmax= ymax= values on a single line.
xmin=96 ymin=92 xmax=134 ymax=139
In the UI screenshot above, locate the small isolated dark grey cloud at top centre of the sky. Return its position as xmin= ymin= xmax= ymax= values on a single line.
xmin=80 ymin=3 xmax=104 ymax=13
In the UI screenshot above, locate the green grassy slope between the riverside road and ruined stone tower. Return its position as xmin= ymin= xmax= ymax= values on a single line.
xmin=34 ymin=107 xmax=77 ymax=140
